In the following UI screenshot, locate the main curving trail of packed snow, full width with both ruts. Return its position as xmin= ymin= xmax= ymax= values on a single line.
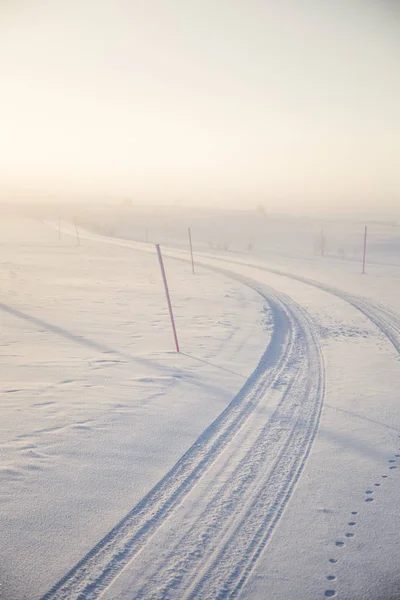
xmin=40 ymin=262 xmax=324 ymax=600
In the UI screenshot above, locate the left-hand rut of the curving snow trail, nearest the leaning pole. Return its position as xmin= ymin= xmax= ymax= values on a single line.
xmin=42 ymin=274 xmax=312 ymax=600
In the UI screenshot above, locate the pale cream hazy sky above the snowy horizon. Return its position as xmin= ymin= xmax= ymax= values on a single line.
xmin=0 ymin=0 xmax=400 ymax=210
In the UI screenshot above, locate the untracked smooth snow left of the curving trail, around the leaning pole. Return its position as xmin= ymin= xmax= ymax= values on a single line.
xmin=0 ymin=221 xmax=270 ymax=600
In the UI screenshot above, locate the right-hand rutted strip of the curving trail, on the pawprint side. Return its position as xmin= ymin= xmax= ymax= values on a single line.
xmin=130 ymin=303 xmax=324 ymax=600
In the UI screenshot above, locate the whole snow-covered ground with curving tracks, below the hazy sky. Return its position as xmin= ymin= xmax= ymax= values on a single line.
xmin=0 ymin=211 xmax=400 ymax=600
